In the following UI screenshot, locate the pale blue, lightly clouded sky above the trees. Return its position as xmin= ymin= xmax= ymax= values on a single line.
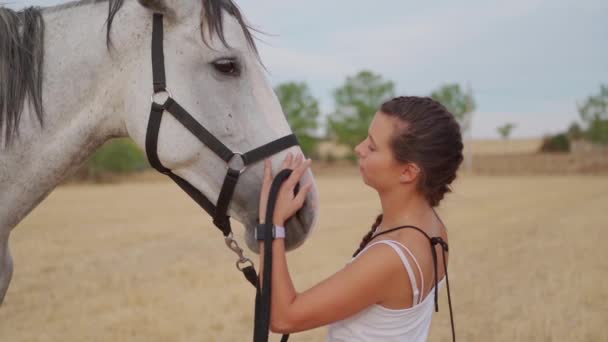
xmin=5 ymin=0 xmax=608 ymax=138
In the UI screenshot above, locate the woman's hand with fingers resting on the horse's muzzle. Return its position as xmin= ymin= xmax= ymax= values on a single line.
xmin=259 ymin=153 xmax=312 ymax=226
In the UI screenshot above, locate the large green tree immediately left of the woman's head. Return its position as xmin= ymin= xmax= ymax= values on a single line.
xmin=327 ymin=70 xmax=395 ymax=148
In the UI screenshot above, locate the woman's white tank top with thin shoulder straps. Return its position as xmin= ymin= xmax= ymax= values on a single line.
xmin=326 ymin=240 xmax=445 ymax=342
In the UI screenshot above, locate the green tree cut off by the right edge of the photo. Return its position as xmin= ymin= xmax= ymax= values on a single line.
xmin=578 ymin=85 xmax=608 ymax=144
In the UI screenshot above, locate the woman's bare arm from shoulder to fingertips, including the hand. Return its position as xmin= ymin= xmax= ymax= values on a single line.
xmin=259 ymin=155 xmax=403 ymax=333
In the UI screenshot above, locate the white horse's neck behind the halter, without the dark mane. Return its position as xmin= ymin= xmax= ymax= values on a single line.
xmin=0 ymin=2 xmax=151 ymax=233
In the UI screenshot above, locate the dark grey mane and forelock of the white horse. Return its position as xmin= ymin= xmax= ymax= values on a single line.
xmin=0 ymin=0 xmax=259 ymax=146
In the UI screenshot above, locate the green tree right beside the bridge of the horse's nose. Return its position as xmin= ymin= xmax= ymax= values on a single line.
xmin=274 ymin=82 xmax=319 ymax=156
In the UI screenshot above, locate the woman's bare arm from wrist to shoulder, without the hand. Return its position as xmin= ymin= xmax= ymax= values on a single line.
xmin=260 ymin=239 xmax=403 ymax=333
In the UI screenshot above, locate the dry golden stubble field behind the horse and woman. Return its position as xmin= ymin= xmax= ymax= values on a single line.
xmin=0 ymin=165 xmax=608 ymax=342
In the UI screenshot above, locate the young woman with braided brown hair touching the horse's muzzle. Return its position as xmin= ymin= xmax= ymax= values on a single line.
xmin=260 ymin=97 xmax=463 ymax=342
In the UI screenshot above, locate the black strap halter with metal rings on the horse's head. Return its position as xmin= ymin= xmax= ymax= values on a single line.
xmin=146 ymin=13 xmax=299 ymax=237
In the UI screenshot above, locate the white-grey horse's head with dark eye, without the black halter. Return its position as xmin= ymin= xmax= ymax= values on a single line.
xmin=118 ymin=0 xmax=318 ymax=251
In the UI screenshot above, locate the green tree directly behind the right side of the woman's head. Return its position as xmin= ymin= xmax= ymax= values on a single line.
xmin=431 ymin=83 xmax=475 ymax=131
